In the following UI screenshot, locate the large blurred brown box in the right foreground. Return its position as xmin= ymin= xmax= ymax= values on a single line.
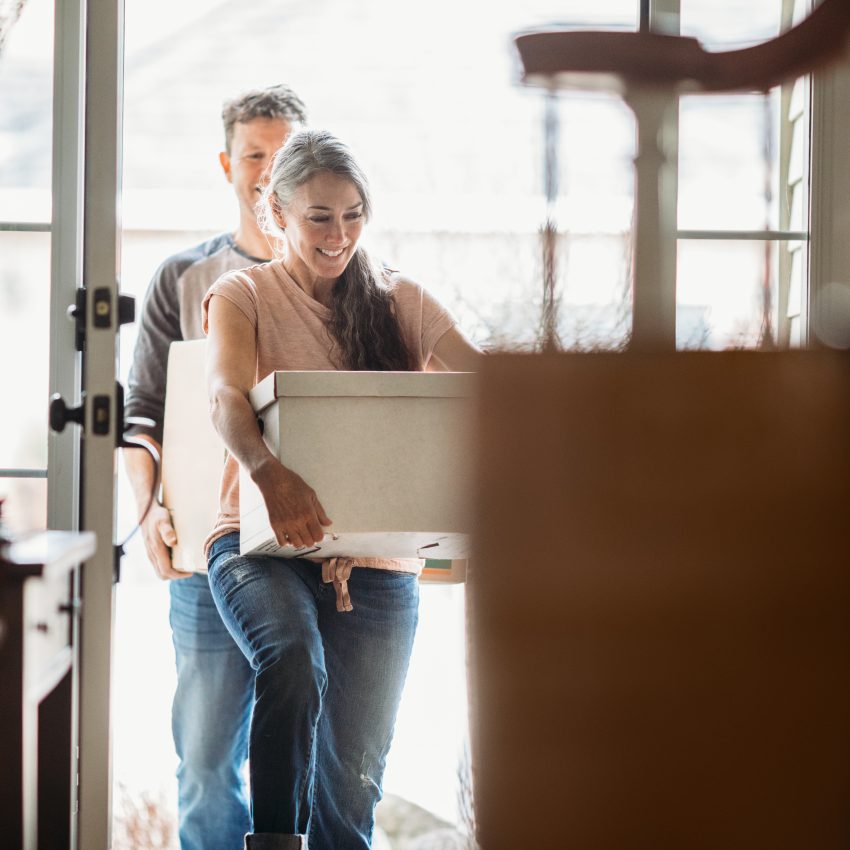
xmin=467 ymin=352 xmax=850 ymax=850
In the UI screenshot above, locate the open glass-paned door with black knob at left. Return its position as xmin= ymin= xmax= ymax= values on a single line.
xmin=0 ymin=0 xmax=123 ymax=850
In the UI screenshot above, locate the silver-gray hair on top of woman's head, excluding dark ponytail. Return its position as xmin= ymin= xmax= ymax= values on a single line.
xmin=257 ymin=130 xmax=372 ymax=239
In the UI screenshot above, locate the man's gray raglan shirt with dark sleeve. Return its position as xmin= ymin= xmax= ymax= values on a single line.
xmin=125 ymin=233 xmax=264 ymax=445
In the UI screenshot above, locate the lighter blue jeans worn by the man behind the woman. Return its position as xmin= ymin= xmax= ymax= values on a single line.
xmin=170 ymin=574 xmax=254 ymax=850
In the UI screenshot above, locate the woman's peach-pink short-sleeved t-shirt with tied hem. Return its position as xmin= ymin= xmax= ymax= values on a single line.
xmin=203 ymin=260 xmax=455 ymax=572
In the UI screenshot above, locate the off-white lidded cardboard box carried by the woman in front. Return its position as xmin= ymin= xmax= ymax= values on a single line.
xmin=239 ymin=372 xmax=474 ymax=560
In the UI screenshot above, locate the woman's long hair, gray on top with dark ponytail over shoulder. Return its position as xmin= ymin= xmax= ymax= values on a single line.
xmin=258 ymin=130 xmax=416 ymax=372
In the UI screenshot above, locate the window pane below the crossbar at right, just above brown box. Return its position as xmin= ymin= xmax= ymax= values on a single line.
xmin=676 ymin=240 xmax=778 ymax=350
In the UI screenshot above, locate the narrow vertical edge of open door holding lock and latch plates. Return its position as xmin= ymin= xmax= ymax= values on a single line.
xmin=78 ymin=0 xmax=124 ymax=850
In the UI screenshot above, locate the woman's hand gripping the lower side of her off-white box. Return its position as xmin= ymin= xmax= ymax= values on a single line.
xmin=251 ymin=457 xmax=331 ymax=548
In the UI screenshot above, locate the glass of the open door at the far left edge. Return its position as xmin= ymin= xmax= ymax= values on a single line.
xmin=0 ymin=0 xmax=53 ymax=532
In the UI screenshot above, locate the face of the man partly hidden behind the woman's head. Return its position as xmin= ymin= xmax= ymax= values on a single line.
xmin=219 ymin=118 xmax=292 ymax=227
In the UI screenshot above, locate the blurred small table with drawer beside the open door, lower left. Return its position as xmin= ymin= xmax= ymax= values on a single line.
xmin=0 ymin=531 xmax=95 ymax=850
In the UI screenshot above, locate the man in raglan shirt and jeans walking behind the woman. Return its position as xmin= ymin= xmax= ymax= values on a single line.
xmin=125 ymin=85 xmax=306 ymax=850
